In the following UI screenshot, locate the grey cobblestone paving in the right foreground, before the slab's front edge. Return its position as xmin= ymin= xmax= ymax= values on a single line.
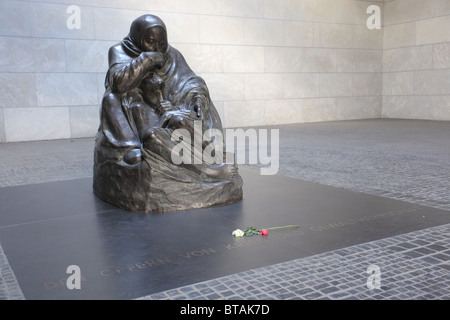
xmin=141 ymin=224 xmax=450 ymax=300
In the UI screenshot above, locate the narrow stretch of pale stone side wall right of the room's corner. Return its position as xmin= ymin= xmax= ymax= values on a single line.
xmin=382 ymin=0 xmax=450 ymax=120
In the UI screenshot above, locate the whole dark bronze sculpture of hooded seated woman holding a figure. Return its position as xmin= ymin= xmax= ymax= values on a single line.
xmin=94 ymin=15 xmax=242 ymax=212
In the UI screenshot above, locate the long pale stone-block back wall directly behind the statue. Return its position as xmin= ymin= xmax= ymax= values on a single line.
xmin=0 ymin=0 xmax=384 ymax=142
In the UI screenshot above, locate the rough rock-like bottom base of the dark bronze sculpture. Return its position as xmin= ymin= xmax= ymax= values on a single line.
xmin=93 ymin=149 xmax=243 ymax=212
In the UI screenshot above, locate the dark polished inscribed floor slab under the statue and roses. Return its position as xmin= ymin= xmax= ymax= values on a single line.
xmin=0 ymin=168 xmax=450 ymax=299
